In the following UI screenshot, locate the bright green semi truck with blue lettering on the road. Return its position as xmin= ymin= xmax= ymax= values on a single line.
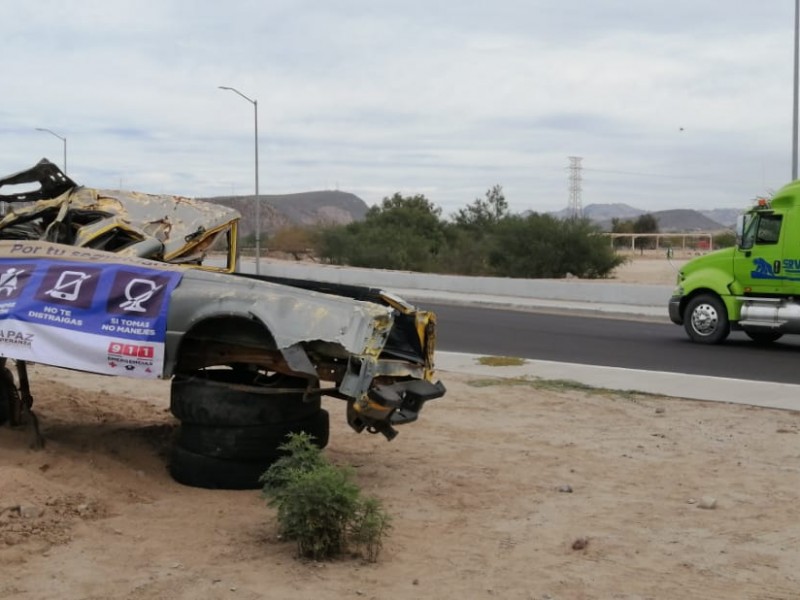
xmin=669 ymin=180 xmax=800 ymax=344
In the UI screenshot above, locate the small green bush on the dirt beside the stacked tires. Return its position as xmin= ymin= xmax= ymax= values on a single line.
xmin=261 ymin=433 xmax=391 ymax=562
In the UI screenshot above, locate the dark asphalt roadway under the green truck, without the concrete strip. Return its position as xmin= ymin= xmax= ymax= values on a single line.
xmin=425 ymin=302 xmax=800 ymax=384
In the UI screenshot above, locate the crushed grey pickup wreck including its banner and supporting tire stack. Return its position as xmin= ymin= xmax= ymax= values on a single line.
xmin=0 ymin=160 xmax=445 ymax=488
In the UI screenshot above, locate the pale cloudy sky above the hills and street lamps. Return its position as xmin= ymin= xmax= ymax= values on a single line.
xmin=0 ymin=0 xmax=795 ymax=216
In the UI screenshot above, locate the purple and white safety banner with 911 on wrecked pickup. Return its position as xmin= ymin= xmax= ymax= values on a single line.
xmin=0 ymin=257 xmax=181 ymax=378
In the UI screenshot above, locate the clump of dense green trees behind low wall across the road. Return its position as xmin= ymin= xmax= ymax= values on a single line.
xmin=319 ymin=186 xmax=623 ymax=278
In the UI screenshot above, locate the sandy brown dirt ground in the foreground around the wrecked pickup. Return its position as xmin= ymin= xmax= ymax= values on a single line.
xmin=0 ymin=261 xmax=800 ymax=600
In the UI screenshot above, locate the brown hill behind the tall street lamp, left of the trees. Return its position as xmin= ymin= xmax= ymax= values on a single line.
xmin=198 ymin=190 xmax=369 ymax=236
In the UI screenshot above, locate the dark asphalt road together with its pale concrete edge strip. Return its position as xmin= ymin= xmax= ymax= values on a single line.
xmin=410 ymin=299 xmax=800 ymax=410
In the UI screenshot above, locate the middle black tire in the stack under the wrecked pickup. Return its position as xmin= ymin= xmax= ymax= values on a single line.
xmin=176 ymin=410 xmax=330 ymax=461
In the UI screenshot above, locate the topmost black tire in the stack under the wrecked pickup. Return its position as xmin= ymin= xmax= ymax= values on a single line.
xmin=170 ymin=369 xmax=322 ymax=427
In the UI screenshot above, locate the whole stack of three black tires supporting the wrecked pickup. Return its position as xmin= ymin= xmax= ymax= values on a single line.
xmin=169 ymin=369 xmax=329 ymax=489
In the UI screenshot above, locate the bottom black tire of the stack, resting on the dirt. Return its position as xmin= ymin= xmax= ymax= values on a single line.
xmin=169 ymin=446 xmax=274 ymax=490
